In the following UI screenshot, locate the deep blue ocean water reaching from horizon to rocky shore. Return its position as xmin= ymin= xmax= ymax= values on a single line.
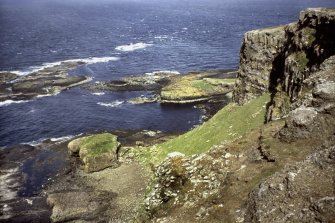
xmin=0 ymin=0 xmax=335 ymax=146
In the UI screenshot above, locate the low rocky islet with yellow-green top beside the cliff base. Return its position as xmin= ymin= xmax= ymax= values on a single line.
xmin=84 ymin=70 xmax=235 ymax=104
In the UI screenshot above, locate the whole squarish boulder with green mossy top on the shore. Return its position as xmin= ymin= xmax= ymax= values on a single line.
xmin=68 ymin=133 xmax=120 ymax=173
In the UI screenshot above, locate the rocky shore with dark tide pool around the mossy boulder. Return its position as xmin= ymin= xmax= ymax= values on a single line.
xmin=0 ymin=130 xmax=177 ymax=223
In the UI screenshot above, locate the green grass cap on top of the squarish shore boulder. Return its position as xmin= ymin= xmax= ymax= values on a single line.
xmin=80 ymin=133 xmax=118 ymax=156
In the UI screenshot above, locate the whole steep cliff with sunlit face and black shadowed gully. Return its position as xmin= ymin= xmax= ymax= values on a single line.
xmin=234 ymin=8 xmax=335 ymax=120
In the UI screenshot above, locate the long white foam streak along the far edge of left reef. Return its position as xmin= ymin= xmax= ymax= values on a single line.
xmin=0 ymin=57 xmax=120 ymax=76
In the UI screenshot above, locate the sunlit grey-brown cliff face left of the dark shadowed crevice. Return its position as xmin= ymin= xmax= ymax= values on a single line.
xmin=233 ymin=26 xmax=287 ymax=104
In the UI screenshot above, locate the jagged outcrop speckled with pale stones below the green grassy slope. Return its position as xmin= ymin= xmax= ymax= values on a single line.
xmin=146 ymin=152 xmax=231 ymax=218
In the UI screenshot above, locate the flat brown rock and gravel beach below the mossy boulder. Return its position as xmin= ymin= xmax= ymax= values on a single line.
xmin=46 ymin=163 xmax=148 ymax=223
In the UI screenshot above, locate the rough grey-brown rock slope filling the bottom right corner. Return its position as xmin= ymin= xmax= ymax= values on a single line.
xmin=244 ymin=145 xmax=335 ymax=223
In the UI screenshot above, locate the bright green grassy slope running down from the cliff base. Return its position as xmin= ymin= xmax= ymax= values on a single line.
xmin=152 ymin=94 xmax=270 ymax=162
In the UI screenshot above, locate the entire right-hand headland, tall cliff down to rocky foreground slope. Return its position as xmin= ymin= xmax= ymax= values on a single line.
xmin=144 ymin=8 xmax=335 ymax=222
